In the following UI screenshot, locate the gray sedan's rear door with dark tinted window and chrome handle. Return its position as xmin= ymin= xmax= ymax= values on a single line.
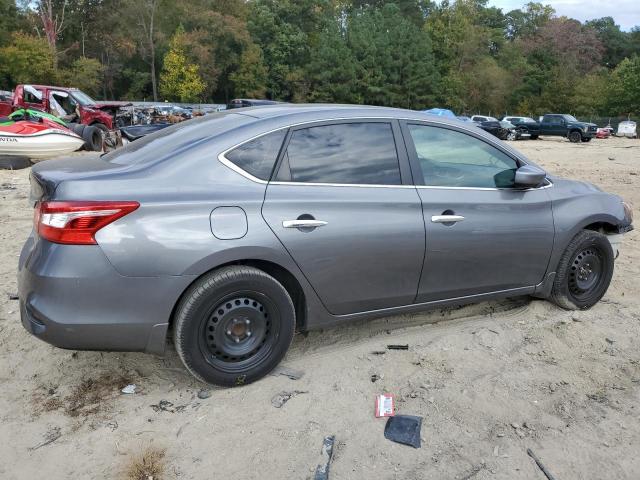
xmin=262 ymin=120 xmax=425 ymax=315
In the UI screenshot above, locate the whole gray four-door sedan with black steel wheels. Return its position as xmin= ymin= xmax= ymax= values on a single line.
xmin=19 ymin=104 xmax=632 ymax=385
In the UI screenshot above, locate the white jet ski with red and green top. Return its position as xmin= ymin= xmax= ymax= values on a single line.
xmin=0 ymin=112 xmax=84 ymax=159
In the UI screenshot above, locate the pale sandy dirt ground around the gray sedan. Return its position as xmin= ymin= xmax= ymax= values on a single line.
xmin=0 ymin=139 xmax=640 ymax=480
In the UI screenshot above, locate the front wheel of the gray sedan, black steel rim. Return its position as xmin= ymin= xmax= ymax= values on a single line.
xmin=551 ymin=230 xmax=614 ymax=310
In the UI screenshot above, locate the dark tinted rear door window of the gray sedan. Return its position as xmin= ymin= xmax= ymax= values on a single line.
xmin=278 ymin=122 xmax=401 ymax=185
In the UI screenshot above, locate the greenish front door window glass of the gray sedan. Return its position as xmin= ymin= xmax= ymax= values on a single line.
xmin=409 ymin=125 xmax=518 ymax=188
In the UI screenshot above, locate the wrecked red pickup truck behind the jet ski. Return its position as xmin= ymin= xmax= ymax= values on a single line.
xmin=0 ymin=85 xmax=131 ymax=146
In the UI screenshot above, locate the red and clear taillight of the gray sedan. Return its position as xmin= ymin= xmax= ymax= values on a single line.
xmin=33 ymin=201 xmax=140 ymax=245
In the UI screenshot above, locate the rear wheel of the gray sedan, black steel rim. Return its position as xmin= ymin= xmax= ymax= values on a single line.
xmin=173 ymin=265 xmax=296 ymax=387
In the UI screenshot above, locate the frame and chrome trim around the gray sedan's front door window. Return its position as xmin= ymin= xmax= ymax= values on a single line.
xmin=400 ymin=120 xmax=553 ymax=192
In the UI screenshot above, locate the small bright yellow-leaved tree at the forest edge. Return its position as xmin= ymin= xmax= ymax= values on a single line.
xmin=160 ymin=29 xmax=206 ymax=102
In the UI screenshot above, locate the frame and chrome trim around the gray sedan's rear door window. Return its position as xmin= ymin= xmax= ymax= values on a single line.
xmin=269 ymin=117 xmax=415 ymax=188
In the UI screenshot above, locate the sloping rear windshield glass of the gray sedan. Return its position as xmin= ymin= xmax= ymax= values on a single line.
xmin=102 ymin=112 xmax=254 ymax=165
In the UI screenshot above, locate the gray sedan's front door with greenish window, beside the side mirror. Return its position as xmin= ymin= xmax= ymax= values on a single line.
xmin=403 ymin=123 xmax=554 ymax=302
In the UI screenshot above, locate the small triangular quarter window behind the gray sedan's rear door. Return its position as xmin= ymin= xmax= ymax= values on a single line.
xmin=225 ymin=129 xmax=287 ymax=180
